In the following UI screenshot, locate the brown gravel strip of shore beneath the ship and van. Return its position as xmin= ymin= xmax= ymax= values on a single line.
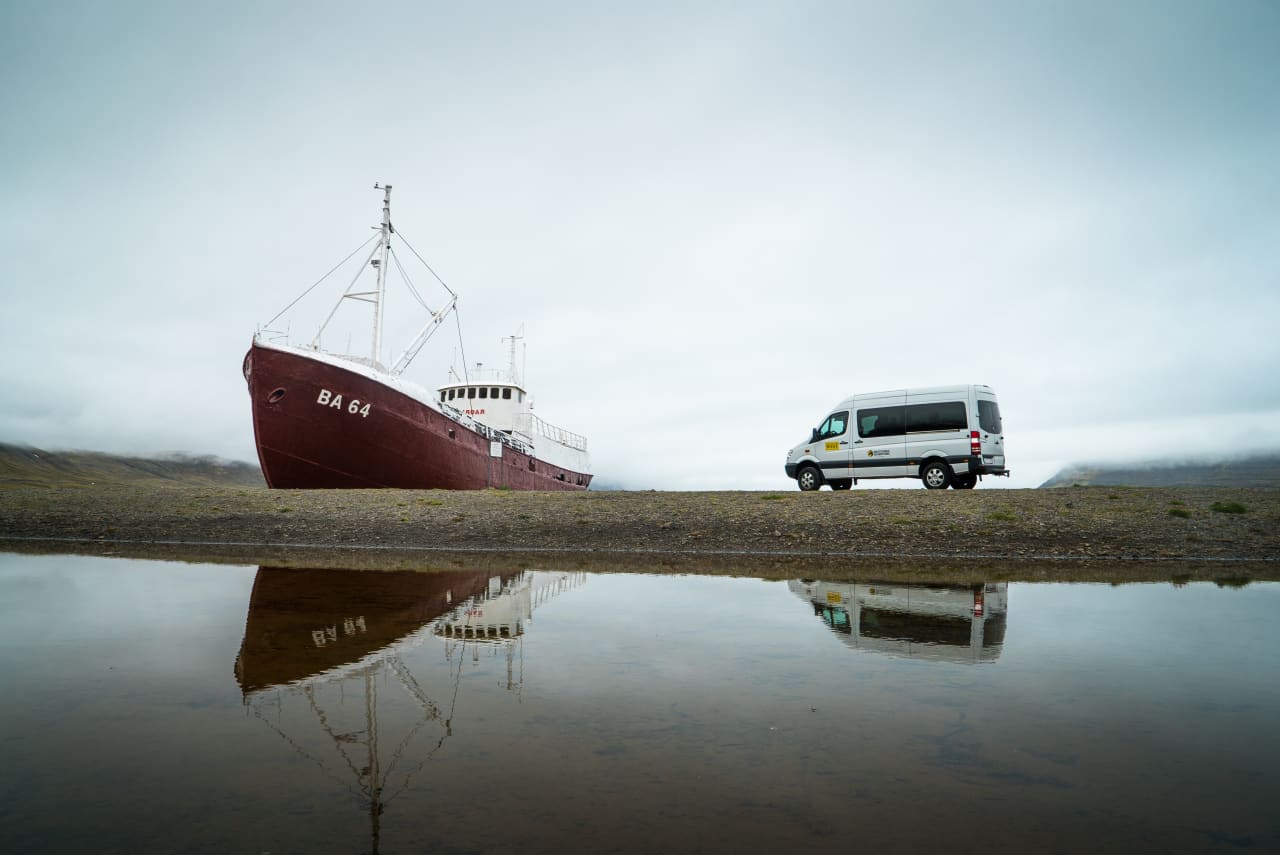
xmin=0 ymin=483 xmax=1280 ymax=581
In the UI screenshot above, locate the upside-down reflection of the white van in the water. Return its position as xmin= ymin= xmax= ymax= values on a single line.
xmin=787 ymin=579 xmax=1009 ymax=662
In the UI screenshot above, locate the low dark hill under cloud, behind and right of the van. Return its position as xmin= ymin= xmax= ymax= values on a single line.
xmin=1041 ymin=454 xmax=1280 ymax=488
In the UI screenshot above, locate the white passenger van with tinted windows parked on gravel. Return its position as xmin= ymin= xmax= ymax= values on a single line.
xmin=786 ymin=385 xmax=1009 ymax=490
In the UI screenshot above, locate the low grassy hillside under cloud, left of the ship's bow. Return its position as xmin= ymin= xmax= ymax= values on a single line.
xmin=0 ymin=443 xmax=266 ymax=489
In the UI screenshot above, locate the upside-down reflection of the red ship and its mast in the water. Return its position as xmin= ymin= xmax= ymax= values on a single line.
xmin=236 ymin=567 xmax=586 ymax=852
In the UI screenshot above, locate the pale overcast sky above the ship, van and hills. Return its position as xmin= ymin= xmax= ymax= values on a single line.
xmin=0 ymin=0 xmax=1280 ymax=489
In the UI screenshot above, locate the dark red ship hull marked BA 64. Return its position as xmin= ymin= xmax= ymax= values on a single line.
xmin=244 ymin=342 xmax=591 ymax=490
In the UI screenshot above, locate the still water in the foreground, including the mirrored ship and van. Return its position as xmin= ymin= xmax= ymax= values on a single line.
xmin=0 ymin=554 xmax=1280 ymax=854
